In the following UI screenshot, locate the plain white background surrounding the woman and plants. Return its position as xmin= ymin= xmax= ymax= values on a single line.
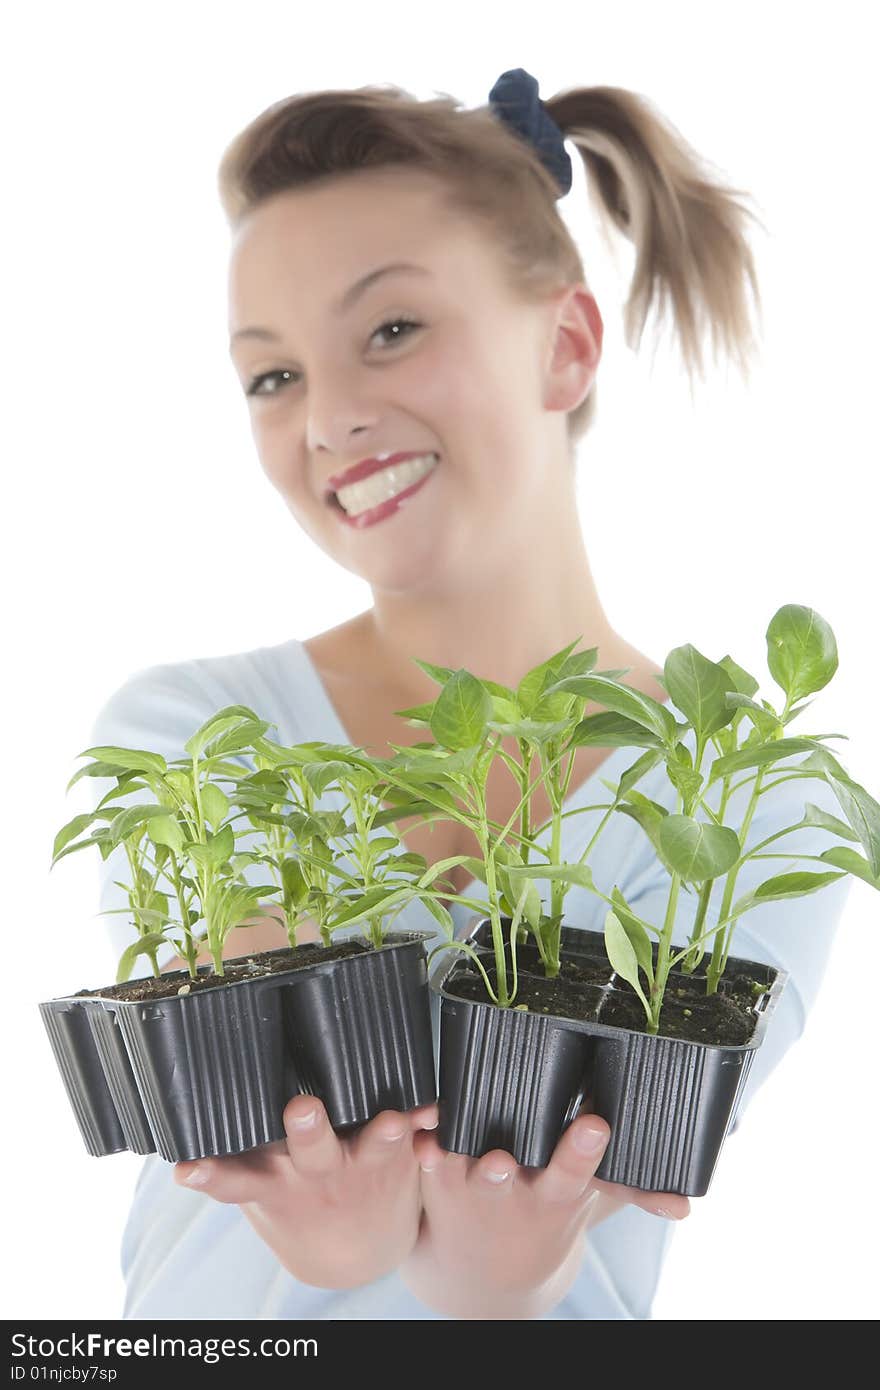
xmin=0 ymin=0 xmax=880 ymax=1319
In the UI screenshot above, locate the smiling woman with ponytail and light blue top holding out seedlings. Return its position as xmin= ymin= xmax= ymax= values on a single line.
xmin=93 ymin=70 xmax=848 ymax=1319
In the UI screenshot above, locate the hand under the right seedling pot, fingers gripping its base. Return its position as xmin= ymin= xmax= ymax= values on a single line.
xmin=400 ymin=1115 xmax=690 ymax=1319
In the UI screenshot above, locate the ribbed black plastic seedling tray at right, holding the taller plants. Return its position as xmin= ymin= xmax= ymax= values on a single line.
xmin=431 ymin=917 xmax=788 ymax=1197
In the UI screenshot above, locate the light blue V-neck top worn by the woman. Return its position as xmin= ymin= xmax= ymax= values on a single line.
xmin=86 ymin=639 xmax=852 ymax=1321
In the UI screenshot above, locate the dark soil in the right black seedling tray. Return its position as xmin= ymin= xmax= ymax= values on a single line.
xmin=443 ymin=958 xmax=765 ymax=1047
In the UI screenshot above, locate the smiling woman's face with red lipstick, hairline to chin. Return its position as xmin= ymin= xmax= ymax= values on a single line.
xmin=229 ymin=168 xmax=598 ymax=592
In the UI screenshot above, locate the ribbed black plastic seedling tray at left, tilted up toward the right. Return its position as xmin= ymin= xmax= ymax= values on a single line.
xmin=40 ymin=931 xmax=437 ymax=1162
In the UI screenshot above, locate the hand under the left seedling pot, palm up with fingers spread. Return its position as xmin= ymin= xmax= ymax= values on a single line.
xmin=174 ymin=1095 xmax=438 ymax=1289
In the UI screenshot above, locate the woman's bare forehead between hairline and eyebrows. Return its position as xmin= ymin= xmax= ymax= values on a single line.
xmin=229 ymin=170 xmax=495 ymax=318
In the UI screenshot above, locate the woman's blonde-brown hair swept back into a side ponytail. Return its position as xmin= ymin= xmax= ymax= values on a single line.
xmin=218 ymin=85 xmax=763 ymax=448
